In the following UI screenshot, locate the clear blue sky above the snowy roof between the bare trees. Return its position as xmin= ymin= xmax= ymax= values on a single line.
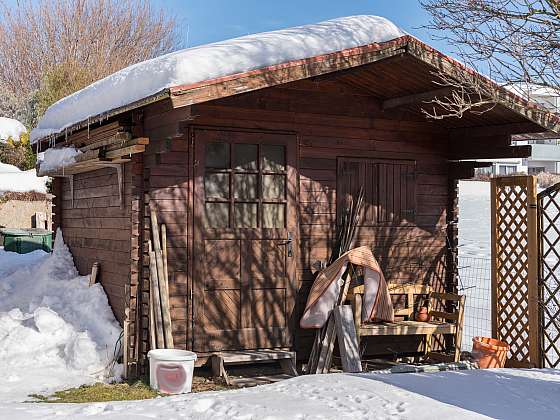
xmin=154 ymin=0 xmax=449 ymax=52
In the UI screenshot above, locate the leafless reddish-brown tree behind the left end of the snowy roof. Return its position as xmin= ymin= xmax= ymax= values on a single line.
xmin=0 ymin=0 xmax=181 ymax=120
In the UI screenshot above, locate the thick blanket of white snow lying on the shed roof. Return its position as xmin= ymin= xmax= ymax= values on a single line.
xmin=31 ymin=16 xmax=405 ymax=141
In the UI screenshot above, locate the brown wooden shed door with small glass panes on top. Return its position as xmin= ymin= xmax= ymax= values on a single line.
xmin=193 ymin=129 xmax=297 ymax=352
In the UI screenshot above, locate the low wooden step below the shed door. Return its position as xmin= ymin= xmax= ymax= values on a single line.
xmin=210 ymin=349 xmax=297 ymax=385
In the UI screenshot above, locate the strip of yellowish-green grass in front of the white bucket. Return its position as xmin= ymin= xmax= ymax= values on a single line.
xmin=30 ymin=381 xmax=159 ymax=403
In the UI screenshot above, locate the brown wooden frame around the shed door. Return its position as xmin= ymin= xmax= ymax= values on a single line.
xmin=187 ymin=124 xmax=300 ymax=354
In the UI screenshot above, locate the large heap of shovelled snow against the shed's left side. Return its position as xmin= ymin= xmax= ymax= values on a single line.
xmin=0 ymin=231 xmax=121 ymax=402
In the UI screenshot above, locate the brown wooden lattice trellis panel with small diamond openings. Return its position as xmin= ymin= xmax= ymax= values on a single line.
xmin=491 ymin=176 xmax=540 ymax=367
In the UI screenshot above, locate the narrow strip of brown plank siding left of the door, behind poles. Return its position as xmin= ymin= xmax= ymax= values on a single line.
xmin=142 ymin=101 xmax=192 ymax=352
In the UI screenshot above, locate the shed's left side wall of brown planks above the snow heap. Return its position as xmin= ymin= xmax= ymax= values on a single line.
xmin=56 ymin=163 xmax=132 ymax=322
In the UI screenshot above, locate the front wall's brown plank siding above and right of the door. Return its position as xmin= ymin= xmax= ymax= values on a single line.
xmin=184 ymin=82 xmax=449 ymax=357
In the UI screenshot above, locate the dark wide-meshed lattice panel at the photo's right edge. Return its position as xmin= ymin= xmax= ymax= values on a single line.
xmin=538 ymin=184 xmax=560 ymax=368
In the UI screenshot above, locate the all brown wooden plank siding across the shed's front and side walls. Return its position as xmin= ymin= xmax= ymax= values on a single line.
xmin=55 ymin=81 xmax=456 ymax=364
